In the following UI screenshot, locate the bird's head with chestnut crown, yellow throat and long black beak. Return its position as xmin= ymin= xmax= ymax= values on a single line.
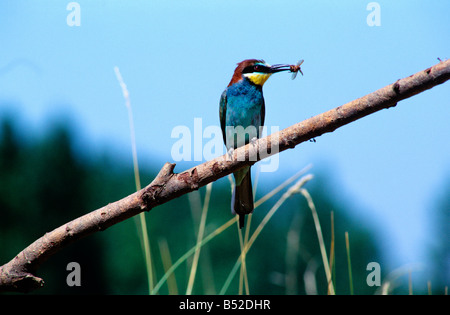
xmin=228 ymin=59 xmax=291 ymax=86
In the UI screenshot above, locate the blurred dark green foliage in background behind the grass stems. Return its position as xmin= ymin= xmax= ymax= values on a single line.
xmin=0 ymin=117 xmax=449 ymax=294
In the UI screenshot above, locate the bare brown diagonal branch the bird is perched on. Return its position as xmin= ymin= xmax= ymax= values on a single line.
xmin=0 ymin=60 xmax=450 ymax=292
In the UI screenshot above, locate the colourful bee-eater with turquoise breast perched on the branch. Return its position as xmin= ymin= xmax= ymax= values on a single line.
xmin=219 ymin=59 xmax=299 ymax=228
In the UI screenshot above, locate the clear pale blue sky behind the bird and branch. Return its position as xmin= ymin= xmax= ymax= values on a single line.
xmin=0 ymin=0 xmax=450 ymax=282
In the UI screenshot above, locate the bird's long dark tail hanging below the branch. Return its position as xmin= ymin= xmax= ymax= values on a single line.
xmin=231 ymin=169 xmax=253 ymax=229
